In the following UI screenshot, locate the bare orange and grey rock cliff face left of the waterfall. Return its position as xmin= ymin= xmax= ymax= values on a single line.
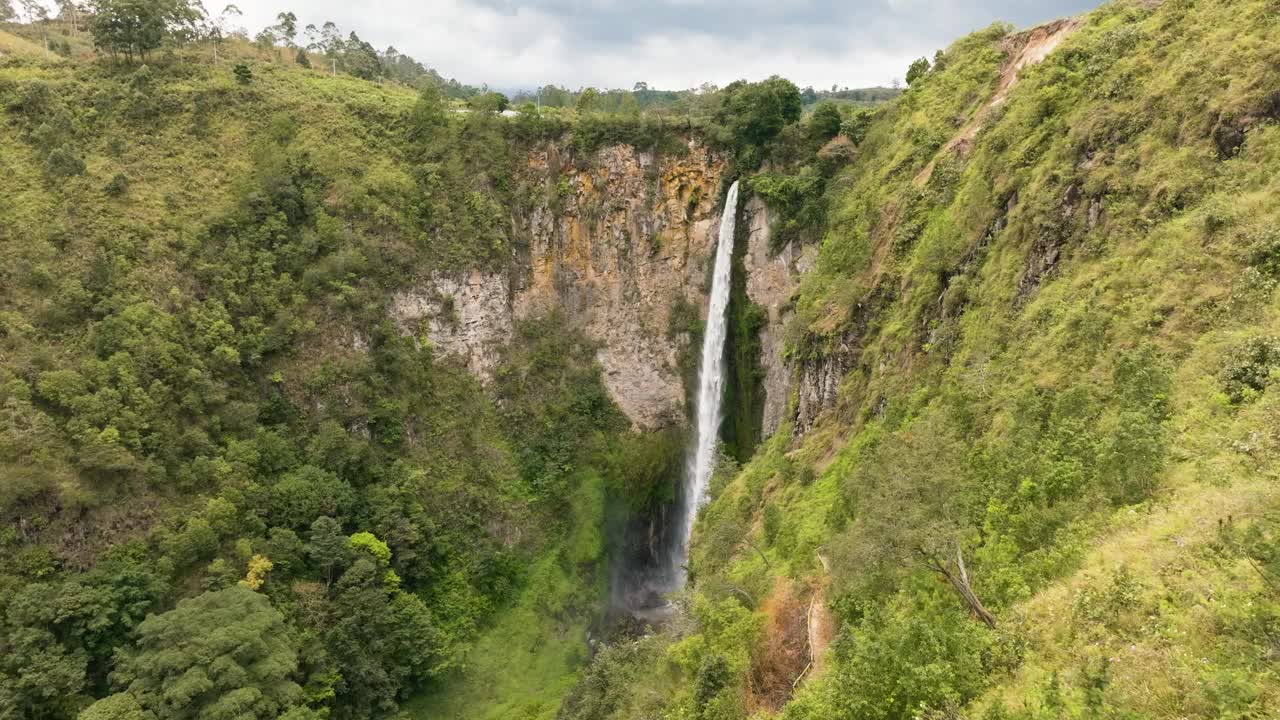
xmin=392 ymin=142 xmax=724 ymax=429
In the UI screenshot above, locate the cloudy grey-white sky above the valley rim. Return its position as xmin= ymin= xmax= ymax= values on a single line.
xmin=225 ymin=0 xmax=1101 ymax=88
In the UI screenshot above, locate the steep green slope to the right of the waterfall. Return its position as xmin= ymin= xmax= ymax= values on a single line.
xmin=562 ymin=0 xmax=1280 ymax=719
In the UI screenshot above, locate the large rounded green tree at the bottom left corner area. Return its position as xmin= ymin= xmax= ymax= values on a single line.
xmin=101 ymin=587 xmax=302 ymax=720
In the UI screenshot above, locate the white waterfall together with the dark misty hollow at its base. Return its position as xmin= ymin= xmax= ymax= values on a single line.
xmin=612 ymin=181 xmax=737 ymax=620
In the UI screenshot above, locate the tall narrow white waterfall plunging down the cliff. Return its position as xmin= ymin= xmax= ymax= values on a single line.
xmin=668 ymin=181 xmax=737 ymax=588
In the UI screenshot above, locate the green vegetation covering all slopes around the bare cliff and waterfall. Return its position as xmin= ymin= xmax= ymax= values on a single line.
xmin=0 ymin=0 xmax=1280 ymax=720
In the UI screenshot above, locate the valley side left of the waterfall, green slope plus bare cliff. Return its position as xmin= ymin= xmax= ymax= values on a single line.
xmin=0 ymin=36 xmax=723 ymax=717
